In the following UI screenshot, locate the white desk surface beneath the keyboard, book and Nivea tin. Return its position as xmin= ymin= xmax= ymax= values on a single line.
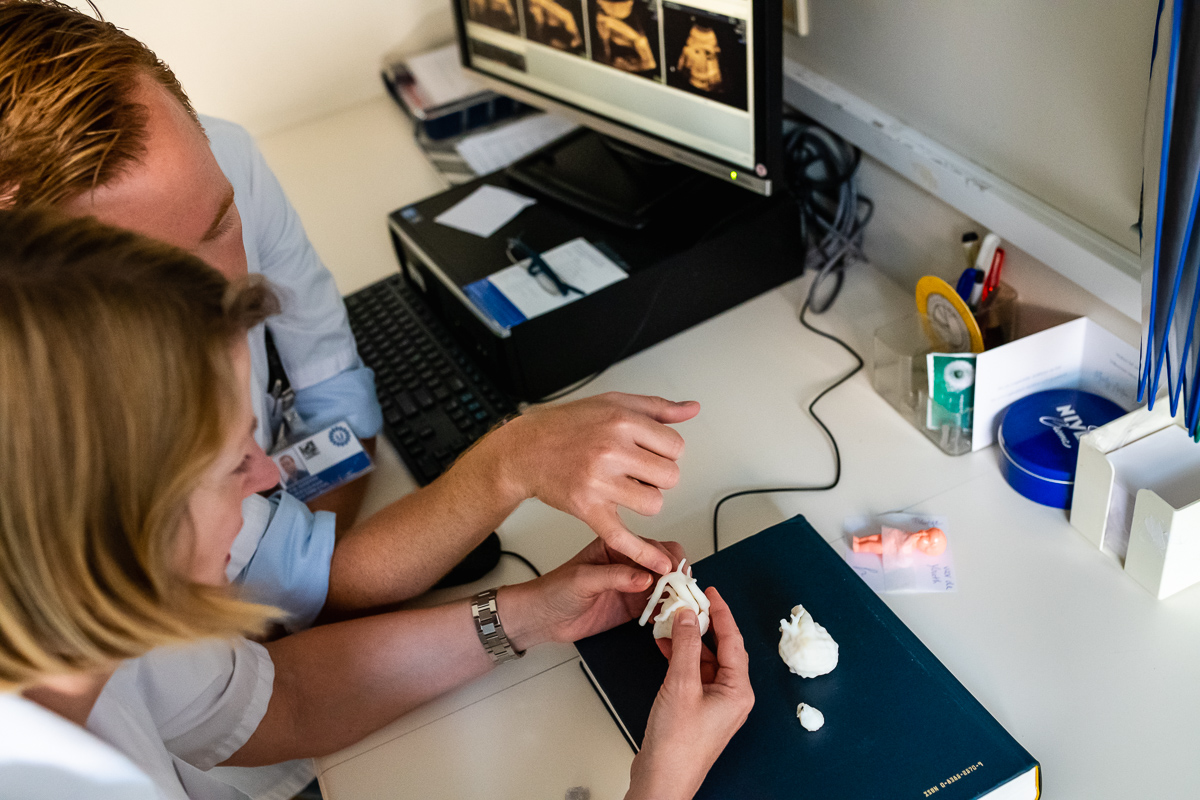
xmin=255 ymin=98 xmax=1200 ymax=800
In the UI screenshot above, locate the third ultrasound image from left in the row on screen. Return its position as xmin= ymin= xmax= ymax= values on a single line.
xmin=589 ymin=0 xmax=662 ymax=80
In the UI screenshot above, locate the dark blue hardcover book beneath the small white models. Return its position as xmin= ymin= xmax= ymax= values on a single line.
xmin=576 ymin=517 xmax=1040 ymax=800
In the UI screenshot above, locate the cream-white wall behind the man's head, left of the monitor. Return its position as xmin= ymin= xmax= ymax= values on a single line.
xmin=72 ymin=0 xmax=454 ymax=134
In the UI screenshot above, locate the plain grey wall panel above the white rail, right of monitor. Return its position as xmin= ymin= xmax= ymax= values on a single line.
xmin=790 ymin=0 xmax=1157 ymax=260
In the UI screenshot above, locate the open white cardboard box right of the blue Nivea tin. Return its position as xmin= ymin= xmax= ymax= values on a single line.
xmin=1070 ymin=410 xmax=1200 ymax=600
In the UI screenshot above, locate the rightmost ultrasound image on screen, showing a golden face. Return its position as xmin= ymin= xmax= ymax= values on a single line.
xmin=662 ymin=2 xmax=746 ymax=110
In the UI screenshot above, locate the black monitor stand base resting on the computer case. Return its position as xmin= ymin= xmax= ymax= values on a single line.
xmin=505 ymin=128 xmax=702 ymax=230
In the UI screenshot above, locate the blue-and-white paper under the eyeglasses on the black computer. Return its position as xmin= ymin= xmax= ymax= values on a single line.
xmin=462 ymin=237 xmax=628 ymax=329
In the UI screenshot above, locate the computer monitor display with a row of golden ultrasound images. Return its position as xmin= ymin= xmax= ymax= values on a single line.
xmin=455 ymin=0 xmax=782 ymax=194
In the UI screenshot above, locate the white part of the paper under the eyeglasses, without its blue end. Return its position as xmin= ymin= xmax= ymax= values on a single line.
xmin=487 ymin=237 xmax=626 ymax=319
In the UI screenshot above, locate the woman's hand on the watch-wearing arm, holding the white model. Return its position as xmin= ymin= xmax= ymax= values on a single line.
xmin=496 ymin=539 xmax=683 ymax=650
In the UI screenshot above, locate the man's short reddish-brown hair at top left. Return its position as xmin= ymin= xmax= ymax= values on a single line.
xmin=0 ymin=0 xmax=196 ymax=209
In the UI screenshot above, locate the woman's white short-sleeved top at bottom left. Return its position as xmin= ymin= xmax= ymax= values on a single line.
xmin=0 ymin=639 xmax=313 ymax=800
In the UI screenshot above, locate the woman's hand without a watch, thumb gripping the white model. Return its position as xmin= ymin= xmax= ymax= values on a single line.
xmin=625 ymin=587 xmax=754 ymax=800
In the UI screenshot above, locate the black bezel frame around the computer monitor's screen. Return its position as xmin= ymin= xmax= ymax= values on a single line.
xmin=451 ymin=0 xmax=784 ymax=197
